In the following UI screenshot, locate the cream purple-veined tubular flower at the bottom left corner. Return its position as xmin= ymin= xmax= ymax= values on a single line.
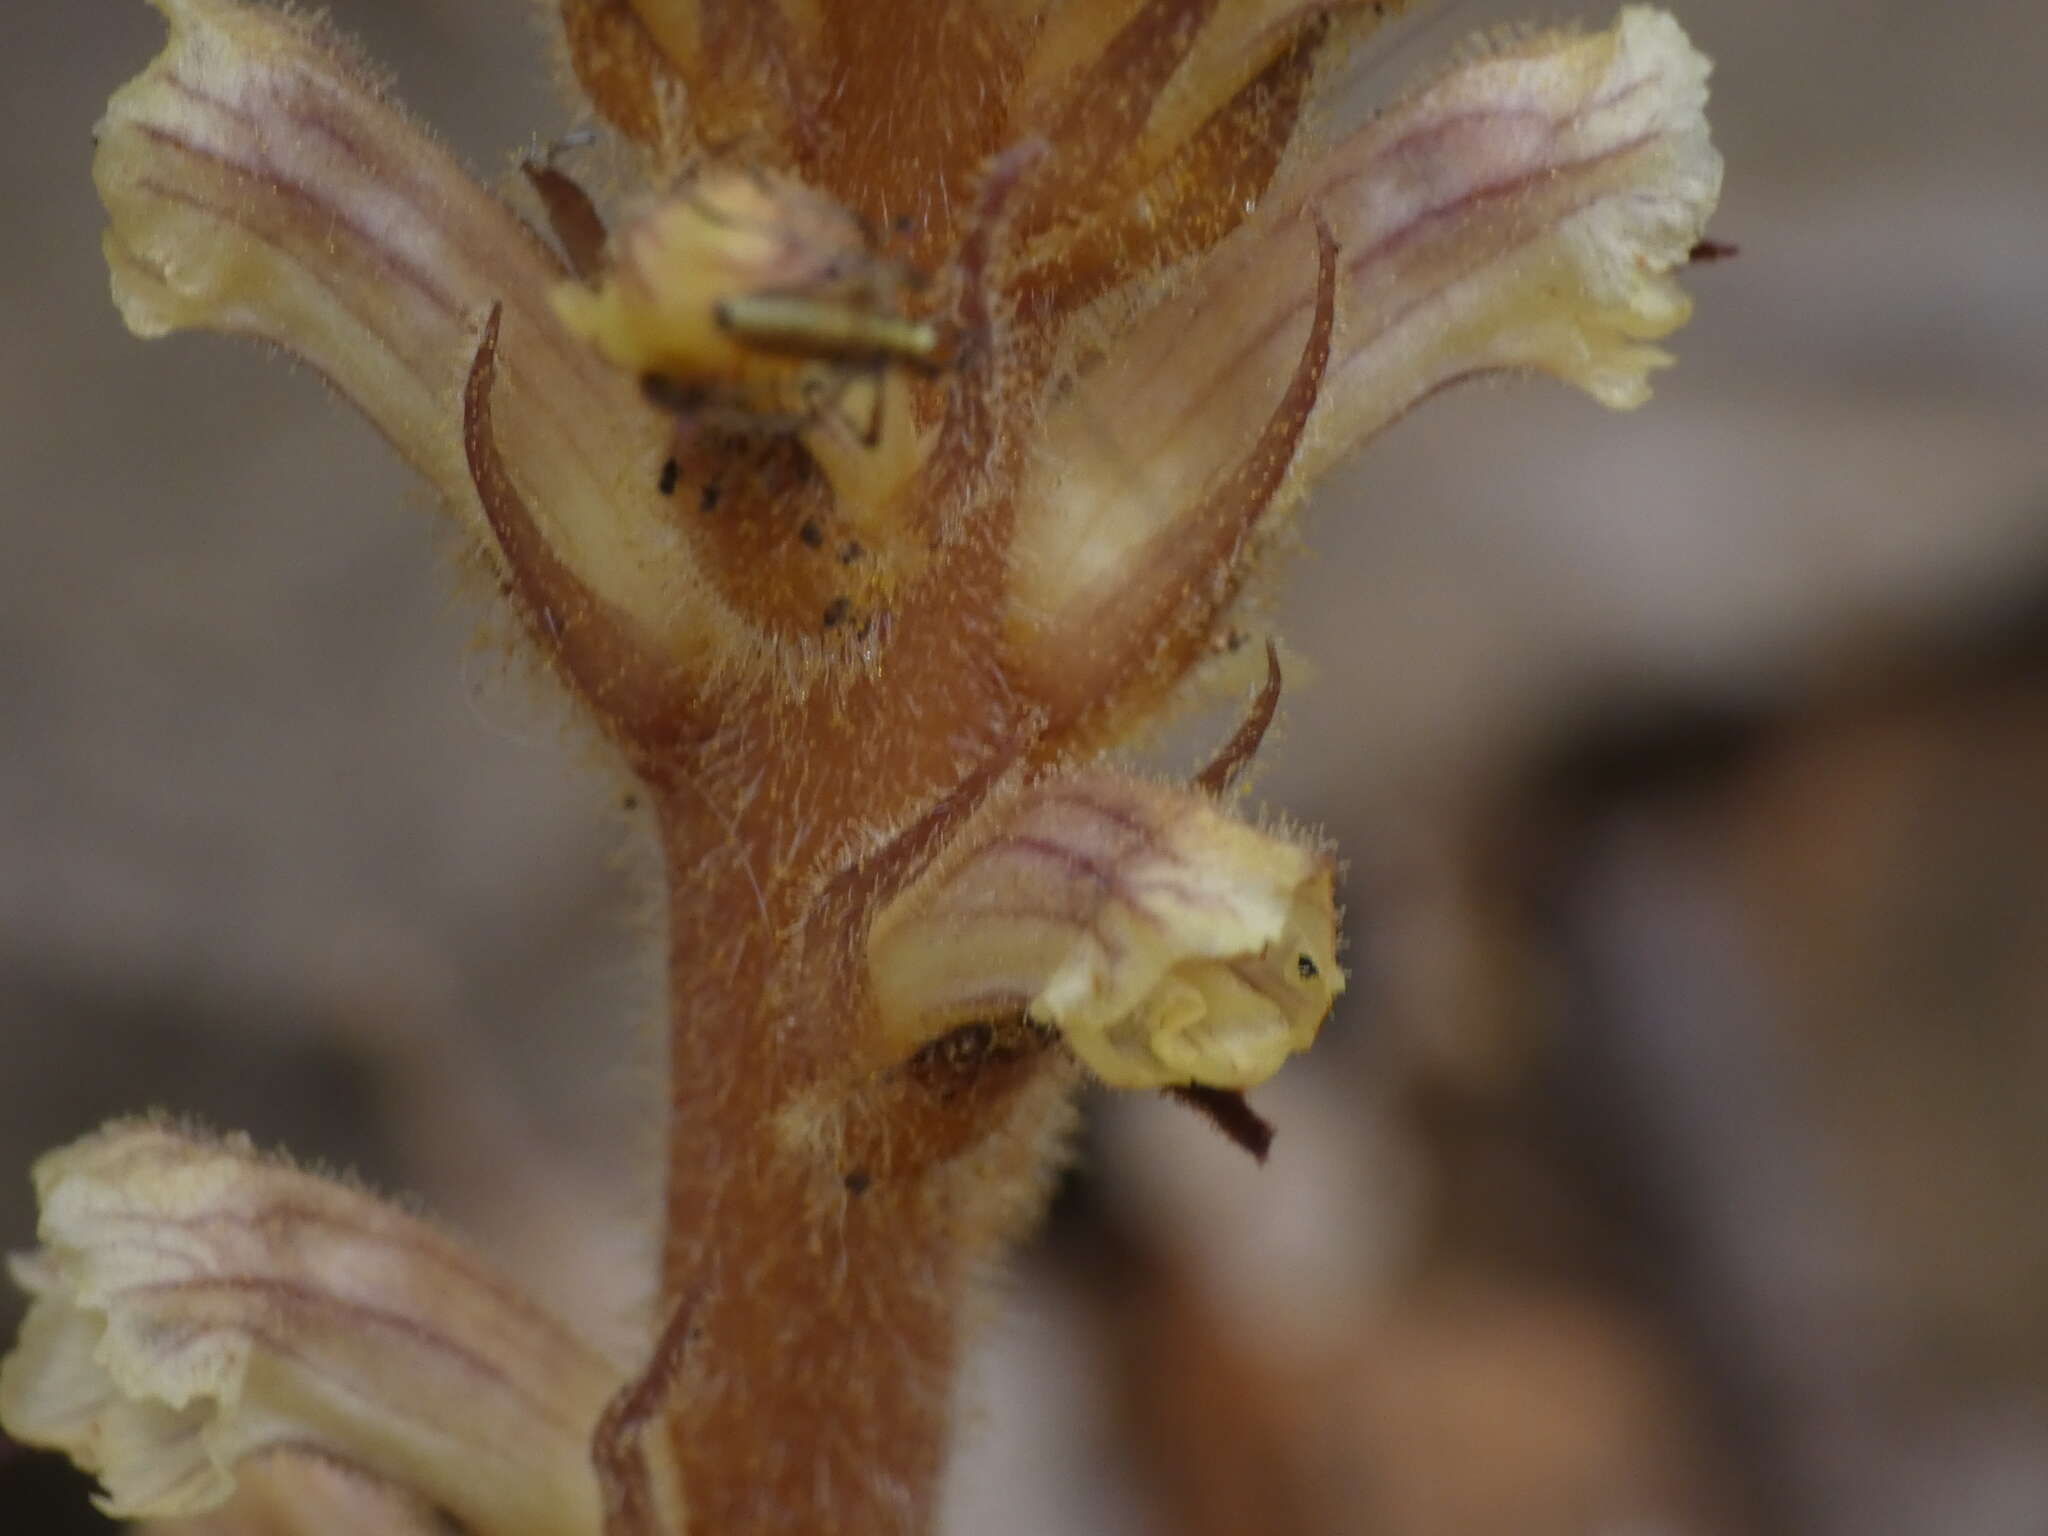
xmin=0 ymin=1122 xmax=621 ymax=1536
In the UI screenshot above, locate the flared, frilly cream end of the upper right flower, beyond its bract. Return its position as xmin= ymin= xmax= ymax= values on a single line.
xmin=1300 ymin=6 xmax=1720 ymax=436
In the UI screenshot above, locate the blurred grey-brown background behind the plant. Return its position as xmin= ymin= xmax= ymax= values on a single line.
xmin=0 ymin=0 xmax=2048 ymax=1536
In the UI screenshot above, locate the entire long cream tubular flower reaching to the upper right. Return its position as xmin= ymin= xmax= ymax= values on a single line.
xmin=1012 ymin=6 xmax=1720 ymax=664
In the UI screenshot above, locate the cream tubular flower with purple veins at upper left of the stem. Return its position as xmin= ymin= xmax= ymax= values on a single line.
xmin=92 ymin=0 xmax=724 ymax=651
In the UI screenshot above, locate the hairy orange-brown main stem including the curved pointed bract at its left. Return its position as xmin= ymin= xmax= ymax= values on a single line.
xmin=467 ymin=322 xmax=1073 ymax=1530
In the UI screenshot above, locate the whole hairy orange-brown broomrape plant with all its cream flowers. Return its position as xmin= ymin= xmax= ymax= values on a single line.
xmin=0 ymin=0 xmax=1720 ymax=1536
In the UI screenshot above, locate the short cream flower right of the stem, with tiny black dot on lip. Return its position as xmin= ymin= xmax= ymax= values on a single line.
xmin=868 ymin=770 xmax=1343 ymax=1087
